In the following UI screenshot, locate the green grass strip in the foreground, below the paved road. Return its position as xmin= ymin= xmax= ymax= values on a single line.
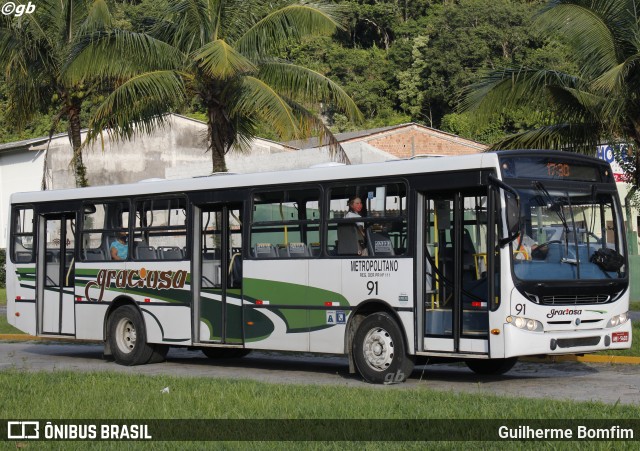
xmin=0 ymin=369 xmax=640 ymax=449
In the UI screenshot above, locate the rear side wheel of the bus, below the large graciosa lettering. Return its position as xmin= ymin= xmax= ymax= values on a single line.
xmin=107 ymin=305 xmax=154 ymax=366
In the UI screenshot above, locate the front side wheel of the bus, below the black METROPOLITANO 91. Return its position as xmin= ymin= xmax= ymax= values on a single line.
xmin=351 ymin=312 xmax=414 ymax=384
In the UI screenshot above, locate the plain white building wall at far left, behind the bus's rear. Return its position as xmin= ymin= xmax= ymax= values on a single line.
xmin=0 ymin=150 xmax=44 ymax=248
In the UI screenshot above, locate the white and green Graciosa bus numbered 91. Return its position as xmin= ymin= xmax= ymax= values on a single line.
xmin=7 ymin=151 xmax=631 ymax=383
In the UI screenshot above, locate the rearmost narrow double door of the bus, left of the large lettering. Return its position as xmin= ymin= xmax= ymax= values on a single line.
xmin=37 ymin=213 xmax=76 ymax=335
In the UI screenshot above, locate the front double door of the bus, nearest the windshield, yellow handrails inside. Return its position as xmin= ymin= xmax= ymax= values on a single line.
xmin=418 ymin=188 xmax=496 ymax=354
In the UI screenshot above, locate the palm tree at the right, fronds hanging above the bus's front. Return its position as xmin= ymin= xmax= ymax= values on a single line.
xmin=461 ymin=0 xmax=640 ymax=189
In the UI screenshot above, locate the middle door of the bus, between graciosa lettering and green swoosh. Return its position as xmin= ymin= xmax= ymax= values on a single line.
xmin=194 ymin=205 xmax=243 ymax=344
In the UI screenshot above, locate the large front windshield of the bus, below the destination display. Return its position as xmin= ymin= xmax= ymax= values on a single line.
xmin=512 ymin=182 xmax=625 ymax=281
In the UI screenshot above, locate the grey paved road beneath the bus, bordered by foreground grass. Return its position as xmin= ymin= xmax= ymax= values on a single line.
xmin=0 ymin=342 xmax=640 ymax=405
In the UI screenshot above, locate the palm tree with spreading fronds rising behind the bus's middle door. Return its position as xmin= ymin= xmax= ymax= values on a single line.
xmin=70 ymin=0 xmax=361 ymax=172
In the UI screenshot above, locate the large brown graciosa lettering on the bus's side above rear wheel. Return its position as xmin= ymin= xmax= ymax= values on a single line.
xmin=84 ymin=268 xmax=187 ymax=302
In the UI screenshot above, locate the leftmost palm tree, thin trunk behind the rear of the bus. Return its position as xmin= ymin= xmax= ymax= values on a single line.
xmin=0 ymin=0 xmax=111 ymax=187
